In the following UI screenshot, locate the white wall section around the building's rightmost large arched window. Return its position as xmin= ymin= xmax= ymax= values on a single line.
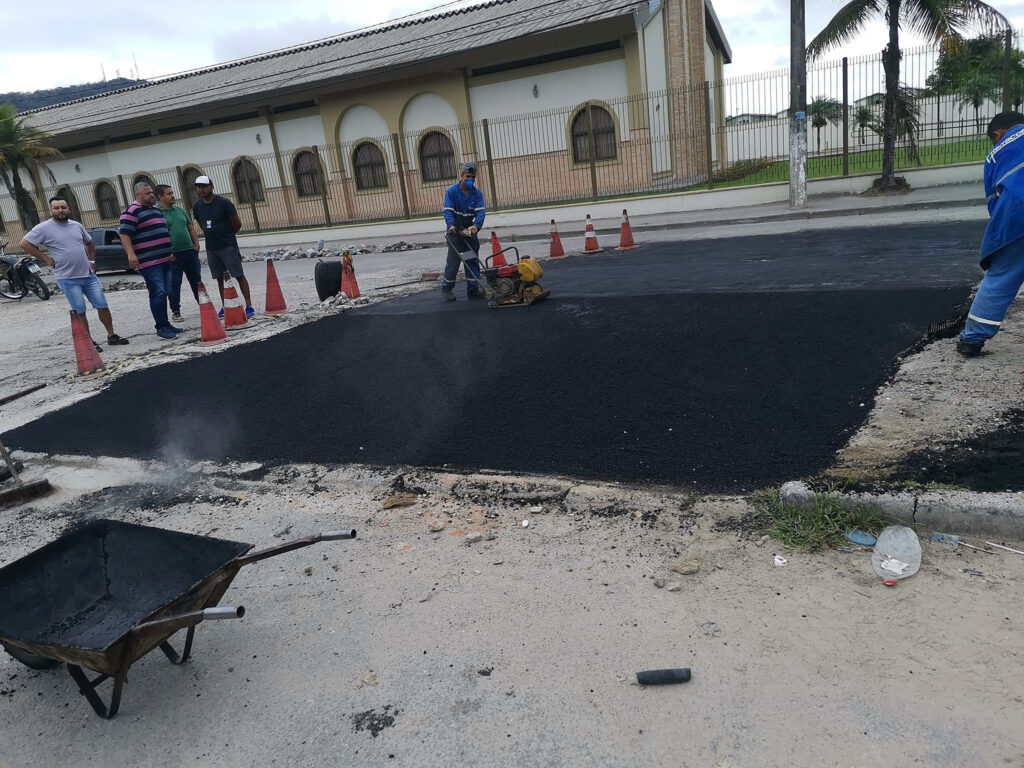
xmin=469 ymin=59 xmax=630 ymax=159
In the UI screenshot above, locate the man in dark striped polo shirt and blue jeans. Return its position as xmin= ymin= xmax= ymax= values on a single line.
xmin=120 ymin=181 xmax=181 ymax=339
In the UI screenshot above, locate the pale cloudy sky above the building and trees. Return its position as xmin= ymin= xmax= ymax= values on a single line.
xmin=0 ymin=0 xmax=1024 ymax=92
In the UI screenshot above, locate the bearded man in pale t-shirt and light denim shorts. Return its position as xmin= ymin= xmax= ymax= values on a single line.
xmin=20 ymin=197 xmax=128 ymax=351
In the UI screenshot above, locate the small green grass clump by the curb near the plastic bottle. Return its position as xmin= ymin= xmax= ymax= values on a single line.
xmin=751 ymin=487 xmax=892 ymax=552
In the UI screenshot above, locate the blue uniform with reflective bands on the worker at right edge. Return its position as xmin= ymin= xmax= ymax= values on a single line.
xmin=961 ymin=125 xmax=1024 ymax=345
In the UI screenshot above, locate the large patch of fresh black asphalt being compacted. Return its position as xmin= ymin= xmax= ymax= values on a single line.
xmin=5 ymin=224 xmax=982 ymax=492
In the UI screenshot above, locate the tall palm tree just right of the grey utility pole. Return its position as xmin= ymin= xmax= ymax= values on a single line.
xmin=807 ymin=0 xmax=1010 ymax=189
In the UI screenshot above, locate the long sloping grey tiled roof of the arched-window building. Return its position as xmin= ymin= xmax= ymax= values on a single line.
xmin=29 ymin=0 xmax=647 ymax=135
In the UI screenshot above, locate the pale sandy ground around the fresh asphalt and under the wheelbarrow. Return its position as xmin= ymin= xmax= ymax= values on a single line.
xmin=0 ymin=205 xmax=1024 ymax=768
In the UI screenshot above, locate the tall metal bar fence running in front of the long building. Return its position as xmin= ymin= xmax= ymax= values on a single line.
xmin=4 ymin=30 xmax=1024 ymax=237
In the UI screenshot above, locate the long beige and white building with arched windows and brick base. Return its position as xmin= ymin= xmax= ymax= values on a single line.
xmin=0 ymin=0 xmax=731 ymax=243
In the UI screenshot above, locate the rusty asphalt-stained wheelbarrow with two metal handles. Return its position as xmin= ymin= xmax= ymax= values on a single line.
xmin=0 ymin=520 xmax=355 ymax=719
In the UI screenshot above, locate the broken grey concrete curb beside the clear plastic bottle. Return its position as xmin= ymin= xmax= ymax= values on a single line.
xmin=779 ymin=480 xmax=1024 ymax=539
